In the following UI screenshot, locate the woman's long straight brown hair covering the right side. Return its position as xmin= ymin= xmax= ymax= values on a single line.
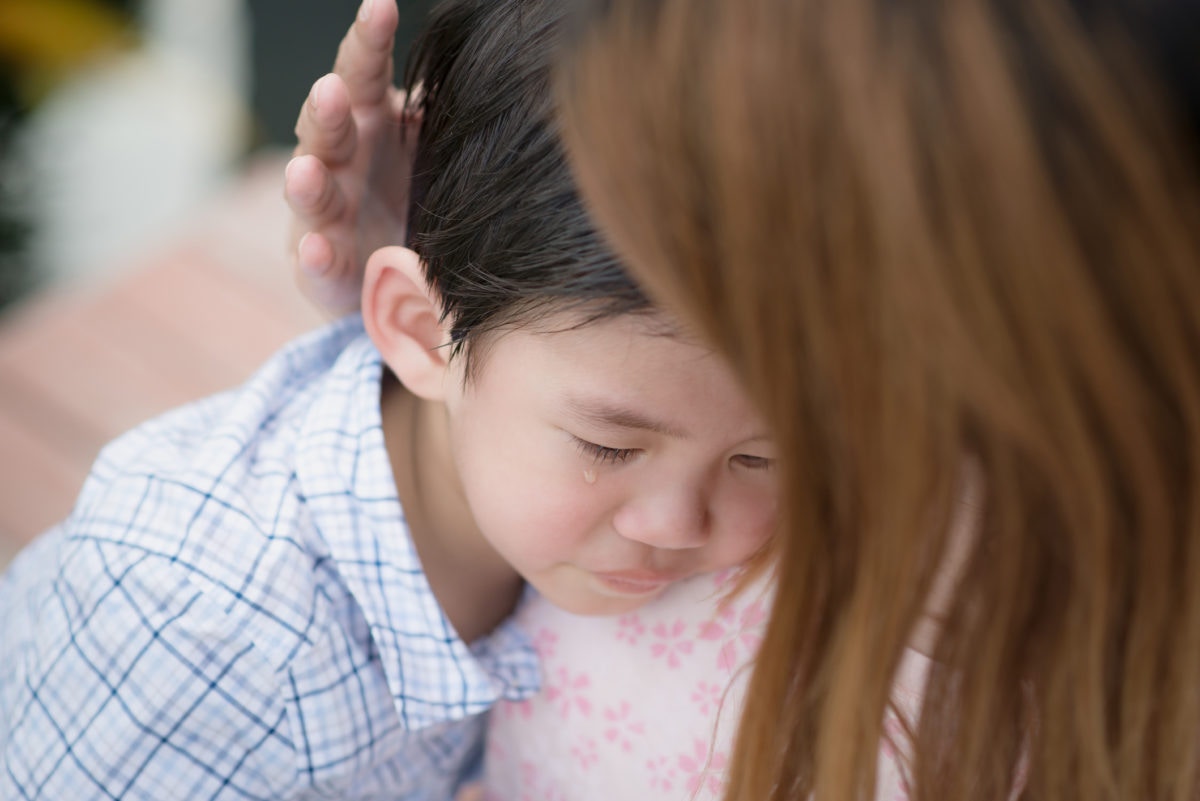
xmin=559 ymin=0 xmax=1200 ymax=801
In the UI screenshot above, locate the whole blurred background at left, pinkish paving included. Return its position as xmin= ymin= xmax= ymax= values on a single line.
xmin=0 ymin=0 xmax=432 ymax=566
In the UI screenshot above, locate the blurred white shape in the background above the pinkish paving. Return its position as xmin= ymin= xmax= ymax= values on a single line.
xmin=10 ymin=0 xmax=251 ymax=287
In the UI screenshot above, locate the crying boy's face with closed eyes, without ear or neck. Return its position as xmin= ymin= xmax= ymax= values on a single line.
xmin=446 ymin=315 xmax=776 ymax=614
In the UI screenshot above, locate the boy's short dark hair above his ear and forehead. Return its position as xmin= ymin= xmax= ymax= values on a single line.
xmin=404 ymin=0 xmax=650 ymax=374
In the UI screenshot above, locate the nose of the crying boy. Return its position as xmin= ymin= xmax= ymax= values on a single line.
xmin=613 ymin=484 xmax=710 ymax=549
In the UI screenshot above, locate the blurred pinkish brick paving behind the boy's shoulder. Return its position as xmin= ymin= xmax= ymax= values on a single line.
xmin=0 ymin=155 xmax=322 ymax=566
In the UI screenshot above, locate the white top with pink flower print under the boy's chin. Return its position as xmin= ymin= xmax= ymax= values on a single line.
xmin=485 ymin=573 xmax=928 ymax=801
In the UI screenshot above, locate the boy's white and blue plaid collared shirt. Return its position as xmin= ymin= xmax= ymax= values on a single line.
xmin=0 ymin=318 xmax=539 ymax=801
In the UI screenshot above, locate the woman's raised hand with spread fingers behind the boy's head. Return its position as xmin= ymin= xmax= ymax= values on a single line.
xmin=283 ymin=0 xmax=420 ymax=314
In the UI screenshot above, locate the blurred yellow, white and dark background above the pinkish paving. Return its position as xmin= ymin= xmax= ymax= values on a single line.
xmin=0 ymin=0 xmax=430 ymax=308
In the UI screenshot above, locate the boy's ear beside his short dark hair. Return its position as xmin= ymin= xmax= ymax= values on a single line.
xmin=362 ymin=246 xmax=450 ymax=401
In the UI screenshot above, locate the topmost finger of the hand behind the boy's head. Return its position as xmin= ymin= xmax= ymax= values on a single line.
xmin=334 ymin=0 xmax=400 ymax=107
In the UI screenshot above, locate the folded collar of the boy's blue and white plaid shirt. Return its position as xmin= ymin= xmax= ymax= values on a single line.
xmin=296 ymin=320 xmax=539 ymax=728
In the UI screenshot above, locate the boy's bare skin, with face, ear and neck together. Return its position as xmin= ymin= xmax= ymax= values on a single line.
xmin=362 ymin=247 xmax=778 ymax=634
